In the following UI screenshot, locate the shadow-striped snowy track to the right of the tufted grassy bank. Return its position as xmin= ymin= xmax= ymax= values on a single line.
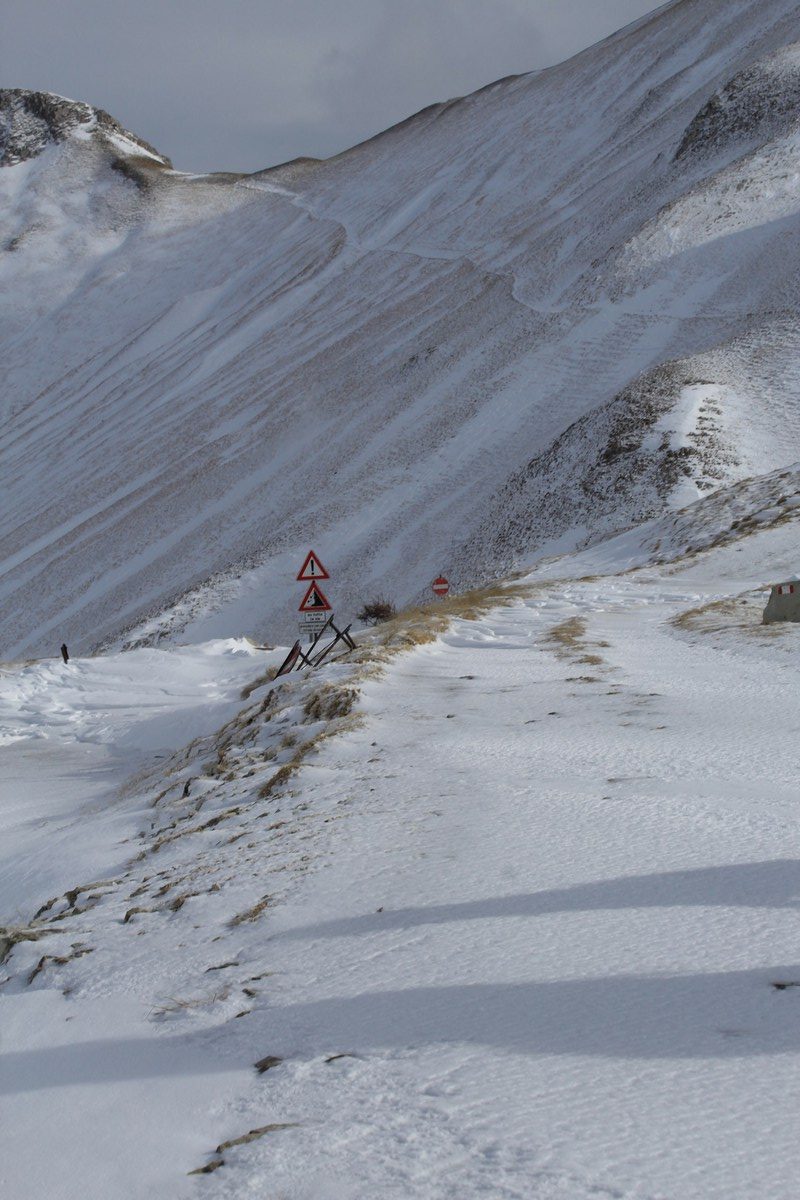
xmin=0 ymin=564 xmax=800 ymax=1200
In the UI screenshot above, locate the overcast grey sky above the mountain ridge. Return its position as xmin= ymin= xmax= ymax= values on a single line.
xmin=0 ymin=0 xmax=658 ymax=170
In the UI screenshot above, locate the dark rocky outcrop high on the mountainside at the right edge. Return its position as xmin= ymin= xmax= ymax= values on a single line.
xmin=675 ymin=43 xmax=800 ymax=161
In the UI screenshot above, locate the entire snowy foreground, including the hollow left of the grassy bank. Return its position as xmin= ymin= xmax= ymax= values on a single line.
xmin=0 ymin=511 xmax=800 ymax=1200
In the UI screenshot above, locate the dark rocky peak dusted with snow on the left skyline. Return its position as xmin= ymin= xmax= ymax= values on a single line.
xmin=0 ymin=88 xmax=172 ymax=167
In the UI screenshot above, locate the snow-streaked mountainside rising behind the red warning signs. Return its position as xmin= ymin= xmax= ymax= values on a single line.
xmin=0 ymin=0 xmax=800 ymax=655
